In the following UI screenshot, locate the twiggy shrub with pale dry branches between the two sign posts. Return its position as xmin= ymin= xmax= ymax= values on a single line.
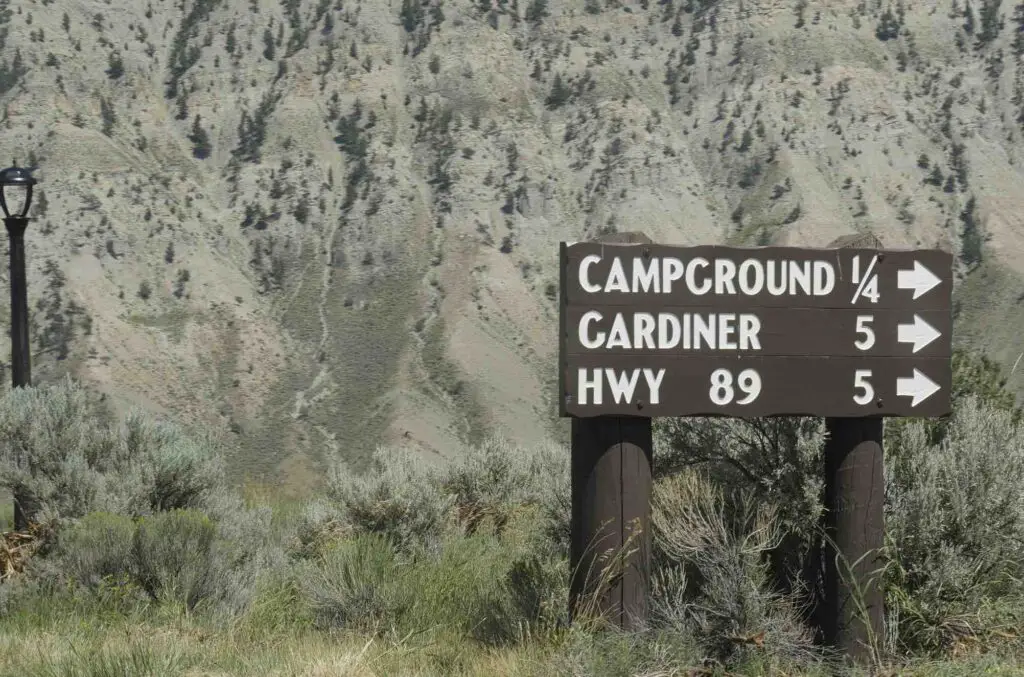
xmin=651 ymin=470 xmax=815 ymax=665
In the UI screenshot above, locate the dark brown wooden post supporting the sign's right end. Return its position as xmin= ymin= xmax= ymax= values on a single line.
xmin=817 ymin=235 xmax=885 ymax=663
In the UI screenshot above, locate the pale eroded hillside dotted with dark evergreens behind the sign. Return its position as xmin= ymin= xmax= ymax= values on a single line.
xmin=0 ymin=0 xmax=1024 ymax=485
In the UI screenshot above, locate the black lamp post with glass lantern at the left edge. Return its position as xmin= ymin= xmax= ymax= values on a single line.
xmin=0 ymin=167 xmax=36 ymax=531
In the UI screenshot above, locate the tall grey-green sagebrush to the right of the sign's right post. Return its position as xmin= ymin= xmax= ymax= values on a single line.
xmin=886 ymin=395 xmax=1024 ymax=650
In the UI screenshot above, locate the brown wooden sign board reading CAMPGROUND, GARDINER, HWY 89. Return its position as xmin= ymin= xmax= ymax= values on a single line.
xmin=559 ymin=242 xmax=952 ymax=418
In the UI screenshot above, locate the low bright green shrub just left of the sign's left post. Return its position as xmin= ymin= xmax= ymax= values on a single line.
xmin=299 ymin=512 xmax=567 ymax=644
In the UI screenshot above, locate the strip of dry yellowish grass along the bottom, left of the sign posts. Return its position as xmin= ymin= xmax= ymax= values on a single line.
xmin=0 ymin=618 xmax=565 ymax=677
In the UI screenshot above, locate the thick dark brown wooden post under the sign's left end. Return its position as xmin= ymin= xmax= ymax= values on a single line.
xmin=559 ymin=232 xmax=653 ymax=629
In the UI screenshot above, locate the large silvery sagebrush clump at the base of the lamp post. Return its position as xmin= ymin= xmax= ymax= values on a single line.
xmin=0 ymin=379 xmax=274 ymax=611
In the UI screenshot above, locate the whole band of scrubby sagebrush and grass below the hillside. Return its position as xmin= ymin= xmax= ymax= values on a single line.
xmin=0 ymin=354 xmax=1024 ymax=675
